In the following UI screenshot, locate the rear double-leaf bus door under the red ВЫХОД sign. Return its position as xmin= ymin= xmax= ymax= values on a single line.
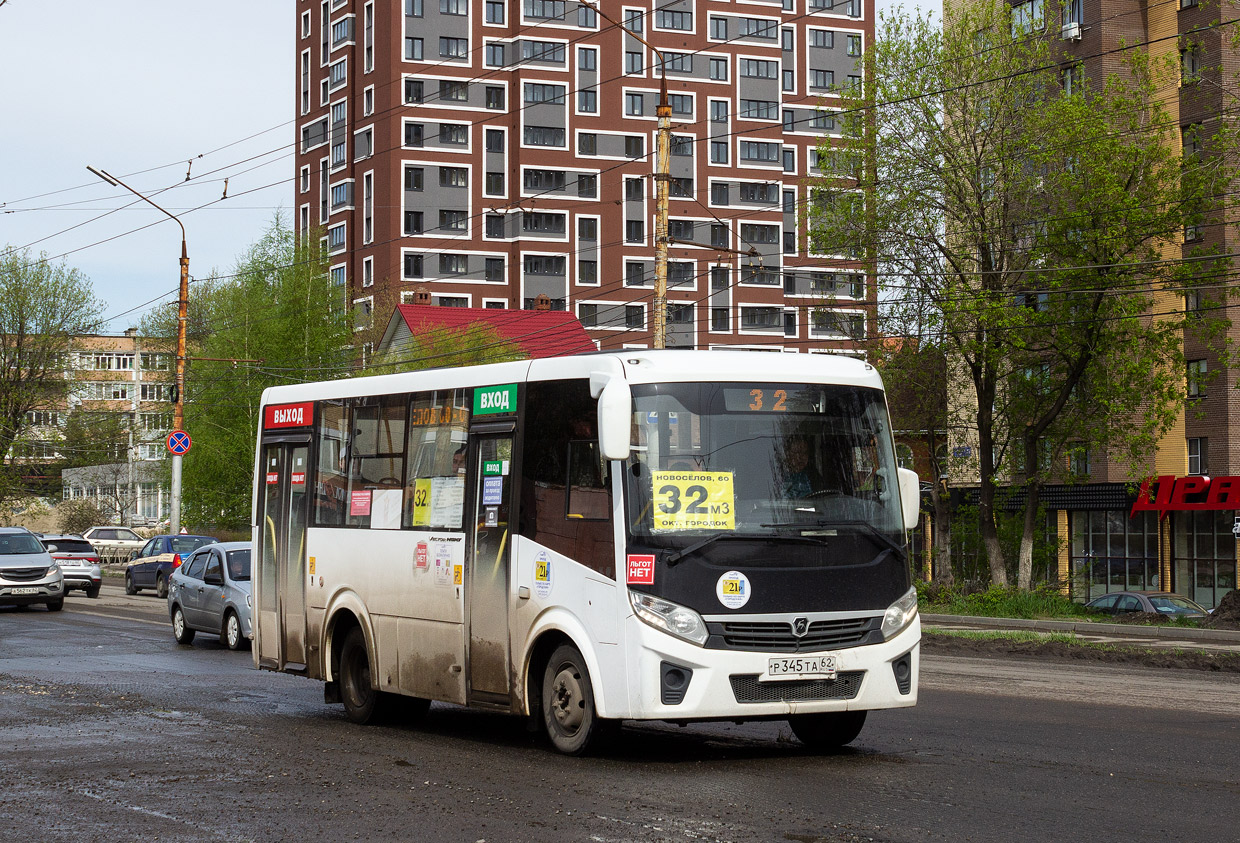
xmin=255 ymin=441 xmax=310 ymax=671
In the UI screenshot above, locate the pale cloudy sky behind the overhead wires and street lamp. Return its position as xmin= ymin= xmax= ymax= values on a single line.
xmin=0 ymin=0 xmax=937 ymax=332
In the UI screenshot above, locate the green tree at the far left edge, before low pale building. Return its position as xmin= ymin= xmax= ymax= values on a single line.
xmin=0 ymin=249 xmax=104 ymax=501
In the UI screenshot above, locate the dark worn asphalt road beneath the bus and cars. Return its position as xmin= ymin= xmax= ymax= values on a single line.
xmin=0 ymin=586 xmax=1240 ymax=843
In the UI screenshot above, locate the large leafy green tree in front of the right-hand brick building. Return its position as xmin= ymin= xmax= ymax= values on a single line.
xmin=811 ymin=0 xmax=1235 ymax=588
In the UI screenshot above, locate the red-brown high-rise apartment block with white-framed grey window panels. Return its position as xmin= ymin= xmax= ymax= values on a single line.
xmin=295 ymin=0 xmax=875 ymax=353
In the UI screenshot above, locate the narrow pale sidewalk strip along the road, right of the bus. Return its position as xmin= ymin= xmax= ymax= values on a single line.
xmin=921 ymin=615 xmax=1240 ymax=653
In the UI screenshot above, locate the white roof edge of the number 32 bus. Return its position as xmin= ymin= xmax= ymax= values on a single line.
xmin=263 ymin=348 xmax=883 ymax=404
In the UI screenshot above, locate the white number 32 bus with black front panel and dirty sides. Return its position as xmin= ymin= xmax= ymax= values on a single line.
xmin=253 ymin=351 xmax=921 ymax=754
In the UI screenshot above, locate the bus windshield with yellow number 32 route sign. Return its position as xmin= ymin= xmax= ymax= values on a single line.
xmin=625 ymin=384 xmax=904 ymax=552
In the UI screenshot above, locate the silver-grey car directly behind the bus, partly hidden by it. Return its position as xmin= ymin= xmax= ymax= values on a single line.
xmin=167 ymin=542 xmax=254 ymax=650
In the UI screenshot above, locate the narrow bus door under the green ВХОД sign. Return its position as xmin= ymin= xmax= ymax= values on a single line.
xmin=465 ymin=423 xmax=516 ymax=704
